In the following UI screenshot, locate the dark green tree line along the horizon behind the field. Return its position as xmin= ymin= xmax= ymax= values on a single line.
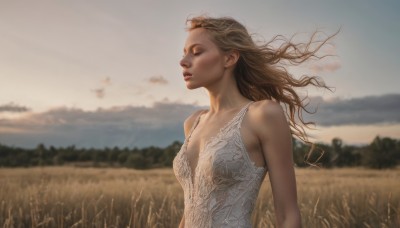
xmin=0 ymin=136 xmax=400 ymax=169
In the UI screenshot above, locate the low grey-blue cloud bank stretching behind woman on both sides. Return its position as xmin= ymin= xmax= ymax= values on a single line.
xmin=0 ymin=94 xmax=400 ymax=148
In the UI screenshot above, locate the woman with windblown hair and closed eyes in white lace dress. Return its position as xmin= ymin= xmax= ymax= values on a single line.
xmin=173 ymin=17 xmax=330 ymax=228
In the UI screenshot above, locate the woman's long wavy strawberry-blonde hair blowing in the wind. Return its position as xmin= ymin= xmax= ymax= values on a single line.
xmin=186 ymin=16 xmax=339 ymax=150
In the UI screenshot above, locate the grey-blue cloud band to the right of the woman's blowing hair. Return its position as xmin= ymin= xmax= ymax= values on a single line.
xmin=304 ymin=94 xmax=400 ymax=126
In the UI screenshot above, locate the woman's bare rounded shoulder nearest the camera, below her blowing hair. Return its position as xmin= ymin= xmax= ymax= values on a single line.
xmin=249 ymin=100 xmax=289 ymax=140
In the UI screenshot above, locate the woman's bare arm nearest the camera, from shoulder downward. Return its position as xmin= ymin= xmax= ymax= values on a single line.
xmin=255 ymin=100 xmax=301 ymax=228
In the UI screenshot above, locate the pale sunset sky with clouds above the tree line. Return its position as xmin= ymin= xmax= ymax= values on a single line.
xmin=0 ymin=0 xmax=400 ymax=148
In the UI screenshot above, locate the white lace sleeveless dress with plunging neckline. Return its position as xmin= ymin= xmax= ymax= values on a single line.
xmin=173 ymin=101 xmax=266 ymax=228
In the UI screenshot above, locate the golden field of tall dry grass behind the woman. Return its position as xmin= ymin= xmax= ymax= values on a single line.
xmin=0 ymin=167 xmax=400 ymax=228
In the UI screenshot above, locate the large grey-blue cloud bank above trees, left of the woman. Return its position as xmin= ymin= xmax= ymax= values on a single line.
xmin=0 ymin=101 xmax=200 ymax=148
